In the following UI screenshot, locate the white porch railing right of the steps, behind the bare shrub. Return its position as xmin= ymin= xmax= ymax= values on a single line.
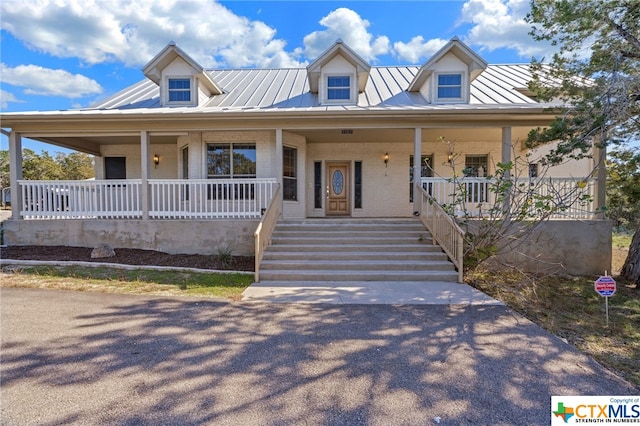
xmin=421 ymin=177 xmax=596 ymax=219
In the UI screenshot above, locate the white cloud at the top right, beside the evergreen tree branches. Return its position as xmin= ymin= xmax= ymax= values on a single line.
xmin=461 ymin=0 xmax=552 ymax=58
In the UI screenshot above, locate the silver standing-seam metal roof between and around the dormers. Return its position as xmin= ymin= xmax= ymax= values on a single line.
xmin=85 ymin=64 xmax=541 ymax=112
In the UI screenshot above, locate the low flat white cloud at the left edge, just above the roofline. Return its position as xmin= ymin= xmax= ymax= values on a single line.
xmin=0 ymin=64 xmax=102 ymax=99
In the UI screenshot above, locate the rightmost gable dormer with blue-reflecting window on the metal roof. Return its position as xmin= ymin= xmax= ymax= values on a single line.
xmin=407 ymin=37 xmax=488 ymax=103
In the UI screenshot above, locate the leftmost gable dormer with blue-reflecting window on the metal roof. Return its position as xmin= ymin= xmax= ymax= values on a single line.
xmin=142 ymin=42 xmax=222 ymax=106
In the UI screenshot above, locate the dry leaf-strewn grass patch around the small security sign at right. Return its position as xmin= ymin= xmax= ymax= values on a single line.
xmin=466 ymin=237 xmax=640 ymax=386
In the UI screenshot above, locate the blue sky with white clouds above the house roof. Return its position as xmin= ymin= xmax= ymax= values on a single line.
xmin=0 ymin=0 xmax=549 ymax=153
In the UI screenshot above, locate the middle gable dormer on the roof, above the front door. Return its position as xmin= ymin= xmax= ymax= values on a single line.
xmin=307 ymin=40 xmax=371 ymax=105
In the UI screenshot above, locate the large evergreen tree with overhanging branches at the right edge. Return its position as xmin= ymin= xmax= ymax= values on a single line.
xmin=527 ymin=0 xmax=640 ymax=282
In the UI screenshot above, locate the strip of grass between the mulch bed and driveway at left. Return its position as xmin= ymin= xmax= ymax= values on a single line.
xmin=0 ymin=266 xmax=253 ymax=301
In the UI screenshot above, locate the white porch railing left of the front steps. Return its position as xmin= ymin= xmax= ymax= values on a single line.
xmin=18 ymin=179 xmax=277 ymax=219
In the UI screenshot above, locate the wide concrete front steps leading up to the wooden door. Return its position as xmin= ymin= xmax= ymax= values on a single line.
xmin=260 ymin=218 xmax=458 ymax=282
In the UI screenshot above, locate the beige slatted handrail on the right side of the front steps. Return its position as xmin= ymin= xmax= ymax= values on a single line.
xmin=414 ymin=185 xmax=465 ymax=283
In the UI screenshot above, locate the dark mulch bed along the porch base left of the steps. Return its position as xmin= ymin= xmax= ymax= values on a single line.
xmin=0 ymin=246 xmax=254 ymax=271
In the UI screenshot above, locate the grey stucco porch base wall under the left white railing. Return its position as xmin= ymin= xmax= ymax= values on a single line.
xmin=3 ymin=219 xmax=259 ymax=256
